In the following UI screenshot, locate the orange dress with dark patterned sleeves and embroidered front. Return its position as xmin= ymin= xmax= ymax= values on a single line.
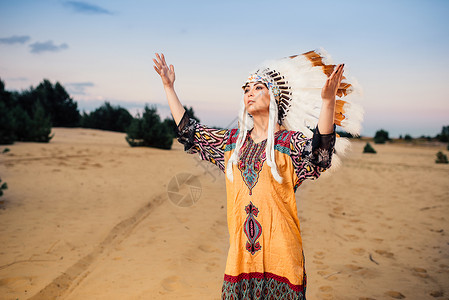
xmin=178 ymin=113 xmax=335 ymax=299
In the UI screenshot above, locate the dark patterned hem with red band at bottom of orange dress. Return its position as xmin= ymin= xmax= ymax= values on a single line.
xmin=221 ymin=273 xmax=306 ymax=300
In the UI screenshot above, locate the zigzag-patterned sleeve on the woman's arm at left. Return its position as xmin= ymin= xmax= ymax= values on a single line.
xmin=177 ymin=112 xmax=229 ymax=172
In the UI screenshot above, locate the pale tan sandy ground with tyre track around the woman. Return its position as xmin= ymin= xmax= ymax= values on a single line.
xmin=0 ymin=128 xmax=449 ymax=300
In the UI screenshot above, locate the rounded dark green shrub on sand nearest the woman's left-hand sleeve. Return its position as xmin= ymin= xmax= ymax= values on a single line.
xmin=126 ymin=106 xmax=173 ymax=149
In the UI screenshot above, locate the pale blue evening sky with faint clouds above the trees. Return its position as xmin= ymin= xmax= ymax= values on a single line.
xmin=0 ymin=0 xmax=449 ymax=137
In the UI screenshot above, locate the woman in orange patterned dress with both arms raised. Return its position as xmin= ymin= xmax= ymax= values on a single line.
xmin=153 ymin=52 xmax=358 ymax=299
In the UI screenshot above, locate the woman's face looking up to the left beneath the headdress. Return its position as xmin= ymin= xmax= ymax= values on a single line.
xmin=243 ymin=82 xmax=270 ymax=116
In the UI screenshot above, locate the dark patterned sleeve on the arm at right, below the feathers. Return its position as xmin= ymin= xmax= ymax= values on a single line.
xmin=290 ymin=125 xmax=335 ymax=187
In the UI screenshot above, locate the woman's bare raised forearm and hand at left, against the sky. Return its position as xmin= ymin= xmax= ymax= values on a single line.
xmin=153 ymin=53 xmax=185 ymax=125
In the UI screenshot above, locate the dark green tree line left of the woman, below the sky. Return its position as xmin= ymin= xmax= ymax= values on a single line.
xmin=0 ymin=79 xmax=199 ymax=149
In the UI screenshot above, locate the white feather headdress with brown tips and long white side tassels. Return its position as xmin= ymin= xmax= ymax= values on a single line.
xmin=226 ymin=49 xmax=363 ymax=182
